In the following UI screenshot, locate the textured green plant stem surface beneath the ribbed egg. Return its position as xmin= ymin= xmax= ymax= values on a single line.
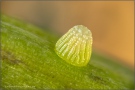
xmin=1 ymin=16 xmax=134 ymax=90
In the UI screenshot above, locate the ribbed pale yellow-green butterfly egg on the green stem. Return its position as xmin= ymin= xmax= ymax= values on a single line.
xmin=55 ymin=25 xmax=92 ymax=66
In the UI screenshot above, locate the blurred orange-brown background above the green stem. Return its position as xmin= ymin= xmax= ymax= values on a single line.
xmin=1 ymin=1 xmax=134 ymax=68
